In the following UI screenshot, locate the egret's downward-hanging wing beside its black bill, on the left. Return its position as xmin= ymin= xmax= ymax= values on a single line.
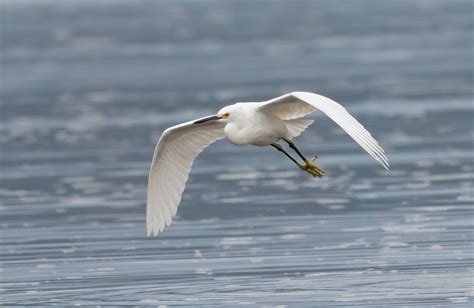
xmin=146 ymin=117 xmax=225 ymax=236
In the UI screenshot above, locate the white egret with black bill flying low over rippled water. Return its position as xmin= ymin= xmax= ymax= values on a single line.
xmin=146 ymin=92 xmax=389 ymax=236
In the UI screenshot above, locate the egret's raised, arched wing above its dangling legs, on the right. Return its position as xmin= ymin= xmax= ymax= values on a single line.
xmin=259 ymin=92 xmax=389 ymax=170
